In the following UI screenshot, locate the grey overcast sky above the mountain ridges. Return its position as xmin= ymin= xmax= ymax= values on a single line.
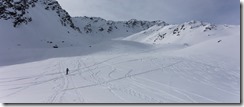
xmin=57 ymin=0 xmax=240 ymax=25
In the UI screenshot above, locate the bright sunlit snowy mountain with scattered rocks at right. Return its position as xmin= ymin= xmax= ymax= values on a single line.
xmin=124 ymin=21 xmax=240 ymax=46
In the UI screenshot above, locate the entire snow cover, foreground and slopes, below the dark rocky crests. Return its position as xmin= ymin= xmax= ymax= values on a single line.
xmin=0 ymin=0 xmax=240 ymax=103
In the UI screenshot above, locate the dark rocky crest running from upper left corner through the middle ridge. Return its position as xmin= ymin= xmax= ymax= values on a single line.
xmin=0 ymin=0 xmax=171 ymax=34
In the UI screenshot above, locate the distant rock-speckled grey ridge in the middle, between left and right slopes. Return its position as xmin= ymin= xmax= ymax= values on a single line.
xmin=72 ymin=16 xmax=169 ymax=36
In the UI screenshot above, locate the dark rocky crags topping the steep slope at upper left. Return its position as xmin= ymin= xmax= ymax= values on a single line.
xmin=0 ymin=0 xmax=80 ymax=31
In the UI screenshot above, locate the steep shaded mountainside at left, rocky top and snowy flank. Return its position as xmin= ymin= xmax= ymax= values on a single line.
xmin=0 ymin=0 xmax=87 ymax=65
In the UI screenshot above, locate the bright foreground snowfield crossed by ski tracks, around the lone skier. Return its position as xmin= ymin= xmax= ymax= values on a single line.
xmin=0 ymin=36 xmax=240 ymax=103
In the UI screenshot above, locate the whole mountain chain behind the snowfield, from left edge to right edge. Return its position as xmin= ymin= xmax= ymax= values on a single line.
xmin=0 ymin=0 xmax=239 ymax=48
